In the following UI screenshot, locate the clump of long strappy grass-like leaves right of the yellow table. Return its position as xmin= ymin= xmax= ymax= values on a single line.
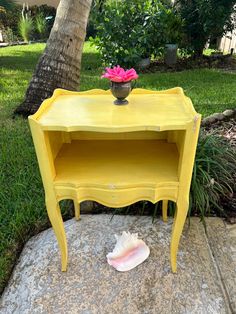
xmin=189 ymin=134 xmax=236 ymax=220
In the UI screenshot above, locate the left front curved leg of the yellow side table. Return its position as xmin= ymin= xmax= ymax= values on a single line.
xmin=46 ymin=199 xmax=68 ymax=271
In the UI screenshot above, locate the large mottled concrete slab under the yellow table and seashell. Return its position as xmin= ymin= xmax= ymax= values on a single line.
xmin=0 ymin=215 xmax=231 ymax=314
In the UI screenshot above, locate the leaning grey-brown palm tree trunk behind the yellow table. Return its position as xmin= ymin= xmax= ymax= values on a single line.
xmin=14 ymin=0 xmax=92 ymax=116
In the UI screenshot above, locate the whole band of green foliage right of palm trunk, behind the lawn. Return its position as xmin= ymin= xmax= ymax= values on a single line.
xmin=88 ymin=0 xmax=236 ymax=66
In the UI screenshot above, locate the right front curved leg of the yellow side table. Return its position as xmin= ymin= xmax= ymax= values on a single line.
xmin=170 ymin=198 xmax=188 ymax=273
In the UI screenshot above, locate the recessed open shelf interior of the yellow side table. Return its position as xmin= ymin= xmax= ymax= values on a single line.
xmin=54 ymin=140 xmax=179 ymax=189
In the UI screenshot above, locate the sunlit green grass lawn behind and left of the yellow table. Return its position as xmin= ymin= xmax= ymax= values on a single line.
xmin=0 ymin=43 xmax=236 ymax=291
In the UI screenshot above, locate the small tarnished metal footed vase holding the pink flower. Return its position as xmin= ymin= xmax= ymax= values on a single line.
xmin=111 ymin=81 xmax=132 ymax=105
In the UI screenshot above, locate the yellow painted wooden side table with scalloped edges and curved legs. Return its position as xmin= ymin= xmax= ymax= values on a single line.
xmin=29 ymin=87 xmax=201 ymax=272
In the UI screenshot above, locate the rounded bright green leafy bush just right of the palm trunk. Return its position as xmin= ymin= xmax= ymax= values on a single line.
xmin=92 ymin=0 xmax=173 ymax=66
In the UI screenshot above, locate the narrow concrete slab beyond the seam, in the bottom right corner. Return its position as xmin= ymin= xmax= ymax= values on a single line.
xmin=207 ymin=218 xmax=236 ymax=313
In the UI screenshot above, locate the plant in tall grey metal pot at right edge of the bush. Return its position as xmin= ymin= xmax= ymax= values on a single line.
xmin=164 ymin=9 xmax=183 ymax=66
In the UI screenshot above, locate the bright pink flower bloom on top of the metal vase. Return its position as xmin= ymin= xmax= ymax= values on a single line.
xmin=101 ymin=65 xmax=138 ymax=82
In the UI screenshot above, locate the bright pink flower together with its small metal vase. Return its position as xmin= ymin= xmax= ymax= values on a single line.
xmin=101 ymin=65 xmax=138 ymax=105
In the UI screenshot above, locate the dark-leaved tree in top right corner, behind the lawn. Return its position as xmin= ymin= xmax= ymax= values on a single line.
xmin=175 ymin=0 xmax=236 ymax=56
